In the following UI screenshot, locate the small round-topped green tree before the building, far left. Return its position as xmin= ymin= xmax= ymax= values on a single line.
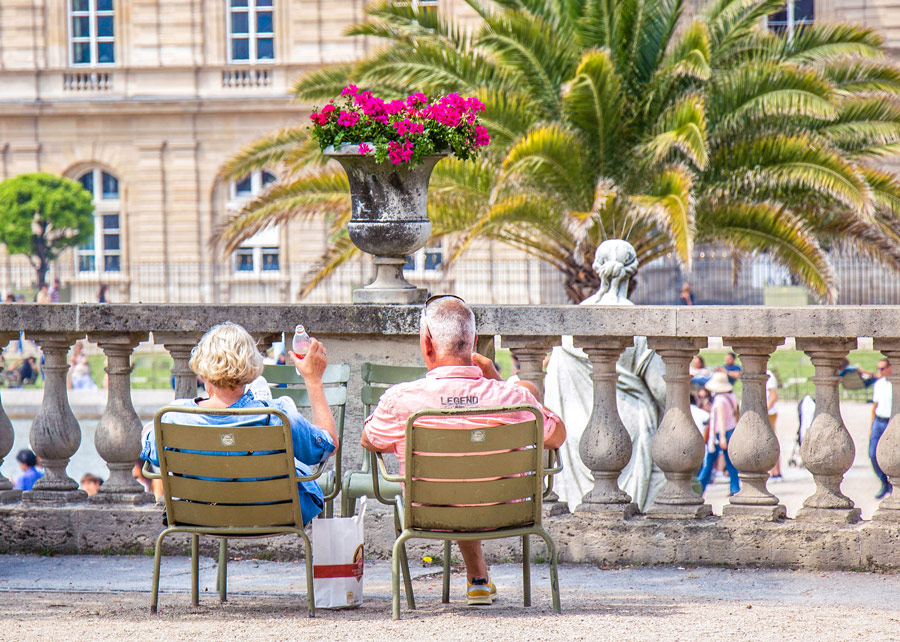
xmin=0 ymin=172 xmax=94 ymax=284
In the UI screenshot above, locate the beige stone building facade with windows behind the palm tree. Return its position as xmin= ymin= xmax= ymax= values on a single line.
xmin=0 ymin=0 xmax=900 ymax=303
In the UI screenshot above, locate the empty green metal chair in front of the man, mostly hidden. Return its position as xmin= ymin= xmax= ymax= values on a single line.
xmin=341 ymin=362 xmax=427 ymax=516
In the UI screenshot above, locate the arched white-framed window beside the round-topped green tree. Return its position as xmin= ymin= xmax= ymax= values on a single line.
xmin=75 ymin=169 xmax=122 ymax=273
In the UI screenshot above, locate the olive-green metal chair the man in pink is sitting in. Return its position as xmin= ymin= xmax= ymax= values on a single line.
xmin=371 ymin=406 xmax=561 ymax=620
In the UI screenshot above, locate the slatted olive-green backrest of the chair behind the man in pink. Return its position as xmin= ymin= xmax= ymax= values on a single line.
xmin=404 ymin=406 xmax=544 ymax=531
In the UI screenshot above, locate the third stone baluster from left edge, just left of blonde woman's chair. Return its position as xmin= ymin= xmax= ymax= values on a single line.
xmin=89 ymin=332 xmax=156 ymax=504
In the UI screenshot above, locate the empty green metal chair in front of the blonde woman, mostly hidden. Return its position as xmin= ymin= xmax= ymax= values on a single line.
xmin=263 ymin=363 xmax=350 ymax=517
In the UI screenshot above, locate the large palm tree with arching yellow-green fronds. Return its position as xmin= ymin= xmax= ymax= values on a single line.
xmin=217 ymin=0 xmax=900 ymax=302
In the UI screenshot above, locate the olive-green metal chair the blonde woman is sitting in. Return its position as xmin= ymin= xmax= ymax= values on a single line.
xmin=144 ymin=406 xmax=327 ymax=617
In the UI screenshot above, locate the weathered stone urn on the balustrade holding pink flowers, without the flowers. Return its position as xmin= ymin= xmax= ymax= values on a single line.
xmin=323 ymin=144 xmax=449 ymax=304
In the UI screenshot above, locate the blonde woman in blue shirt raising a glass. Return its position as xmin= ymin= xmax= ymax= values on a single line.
xmin=141 ymin=323 xmax=338 ymax=524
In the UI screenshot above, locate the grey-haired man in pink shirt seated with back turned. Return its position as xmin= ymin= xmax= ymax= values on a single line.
xmin=361 ymin=295 xmax=566 ymax=605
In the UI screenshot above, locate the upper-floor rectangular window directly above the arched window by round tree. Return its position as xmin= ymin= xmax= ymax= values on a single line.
xmin=69 ymin=0 xmax=116 ymax=67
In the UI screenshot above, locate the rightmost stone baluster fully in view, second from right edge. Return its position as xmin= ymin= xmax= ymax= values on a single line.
xmin=797 ymin=338 xmax=860 ymax=524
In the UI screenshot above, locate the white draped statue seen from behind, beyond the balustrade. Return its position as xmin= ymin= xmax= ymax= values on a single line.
xmin=544 ymin=239 xmax=666 ymax=511
